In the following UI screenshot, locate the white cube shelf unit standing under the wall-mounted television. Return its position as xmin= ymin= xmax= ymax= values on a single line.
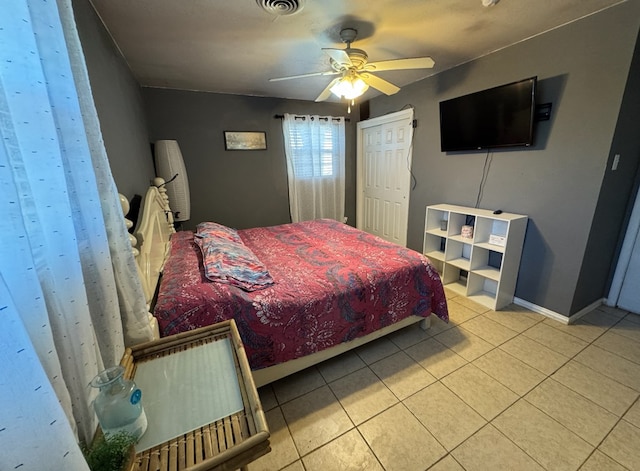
xmin=423 ymin=204 xmax=528 ymax=310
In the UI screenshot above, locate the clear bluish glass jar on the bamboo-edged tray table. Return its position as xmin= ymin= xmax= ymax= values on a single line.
xmin=91 ymin=366 xmax=147 ymax=440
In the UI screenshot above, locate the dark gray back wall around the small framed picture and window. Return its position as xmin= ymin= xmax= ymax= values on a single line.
xmin=142 ymin=88 xmax=357 ymax=229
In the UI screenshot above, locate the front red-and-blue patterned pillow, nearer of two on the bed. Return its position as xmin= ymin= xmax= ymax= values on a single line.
xmin=194 ymin=236 xmax=274 ymax=291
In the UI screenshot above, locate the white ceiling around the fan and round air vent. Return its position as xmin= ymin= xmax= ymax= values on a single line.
xmin=91 ymin=0 xmax=626 ymax=100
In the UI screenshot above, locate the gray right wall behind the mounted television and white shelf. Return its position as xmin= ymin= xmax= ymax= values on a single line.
xmin=370 ymin=2 xmax=640 ymax=315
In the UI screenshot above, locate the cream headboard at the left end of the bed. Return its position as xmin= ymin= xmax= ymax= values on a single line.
xmin=120 ymin=178 xmax=175 ymax=338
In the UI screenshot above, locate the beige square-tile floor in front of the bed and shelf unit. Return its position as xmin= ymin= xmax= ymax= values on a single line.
xmin=249 ymin=293 xmax=640 ymax=471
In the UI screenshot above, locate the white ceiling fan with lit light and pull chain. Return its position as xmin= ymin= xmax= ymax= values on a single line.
xmin=269 ymin=28 xmax=435 ymax=103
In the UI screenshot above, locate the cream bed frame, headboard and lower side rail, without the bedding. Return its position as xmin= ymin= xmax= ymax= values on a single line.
xmin=127 ymin=178 xmax=431 ymax=387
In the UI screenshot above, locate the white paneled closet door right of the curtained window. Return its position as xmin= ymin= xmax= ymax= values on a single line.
xmin=356 ymin=109 xmax=413 ymax=246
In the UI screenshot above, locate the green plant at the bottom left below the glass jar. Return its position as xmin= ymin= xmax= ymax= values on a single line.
xmin=82 ymin=432 xmax=136 ymax=471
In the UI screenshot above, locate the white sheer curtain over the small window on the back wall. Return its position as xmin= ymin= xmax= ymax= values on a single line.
xmin=282 ymin=114 xmax=345 ymax=222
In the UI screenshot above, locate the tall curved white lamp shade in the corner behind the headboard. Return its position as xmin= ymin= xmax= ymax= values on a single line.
xmin=155 ymin=140 xmax=191 ymax=221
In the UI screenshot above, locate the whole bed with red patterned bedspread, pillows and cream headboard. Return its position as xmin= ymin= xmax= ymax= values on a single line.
xmin=129 ymin=179 xmax=448 ymax=387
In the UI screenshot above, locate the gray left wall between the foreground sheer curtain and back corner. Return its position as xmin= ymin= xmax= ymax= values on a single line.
xmin=73 ymin=0 xmax=155 ymax=199
